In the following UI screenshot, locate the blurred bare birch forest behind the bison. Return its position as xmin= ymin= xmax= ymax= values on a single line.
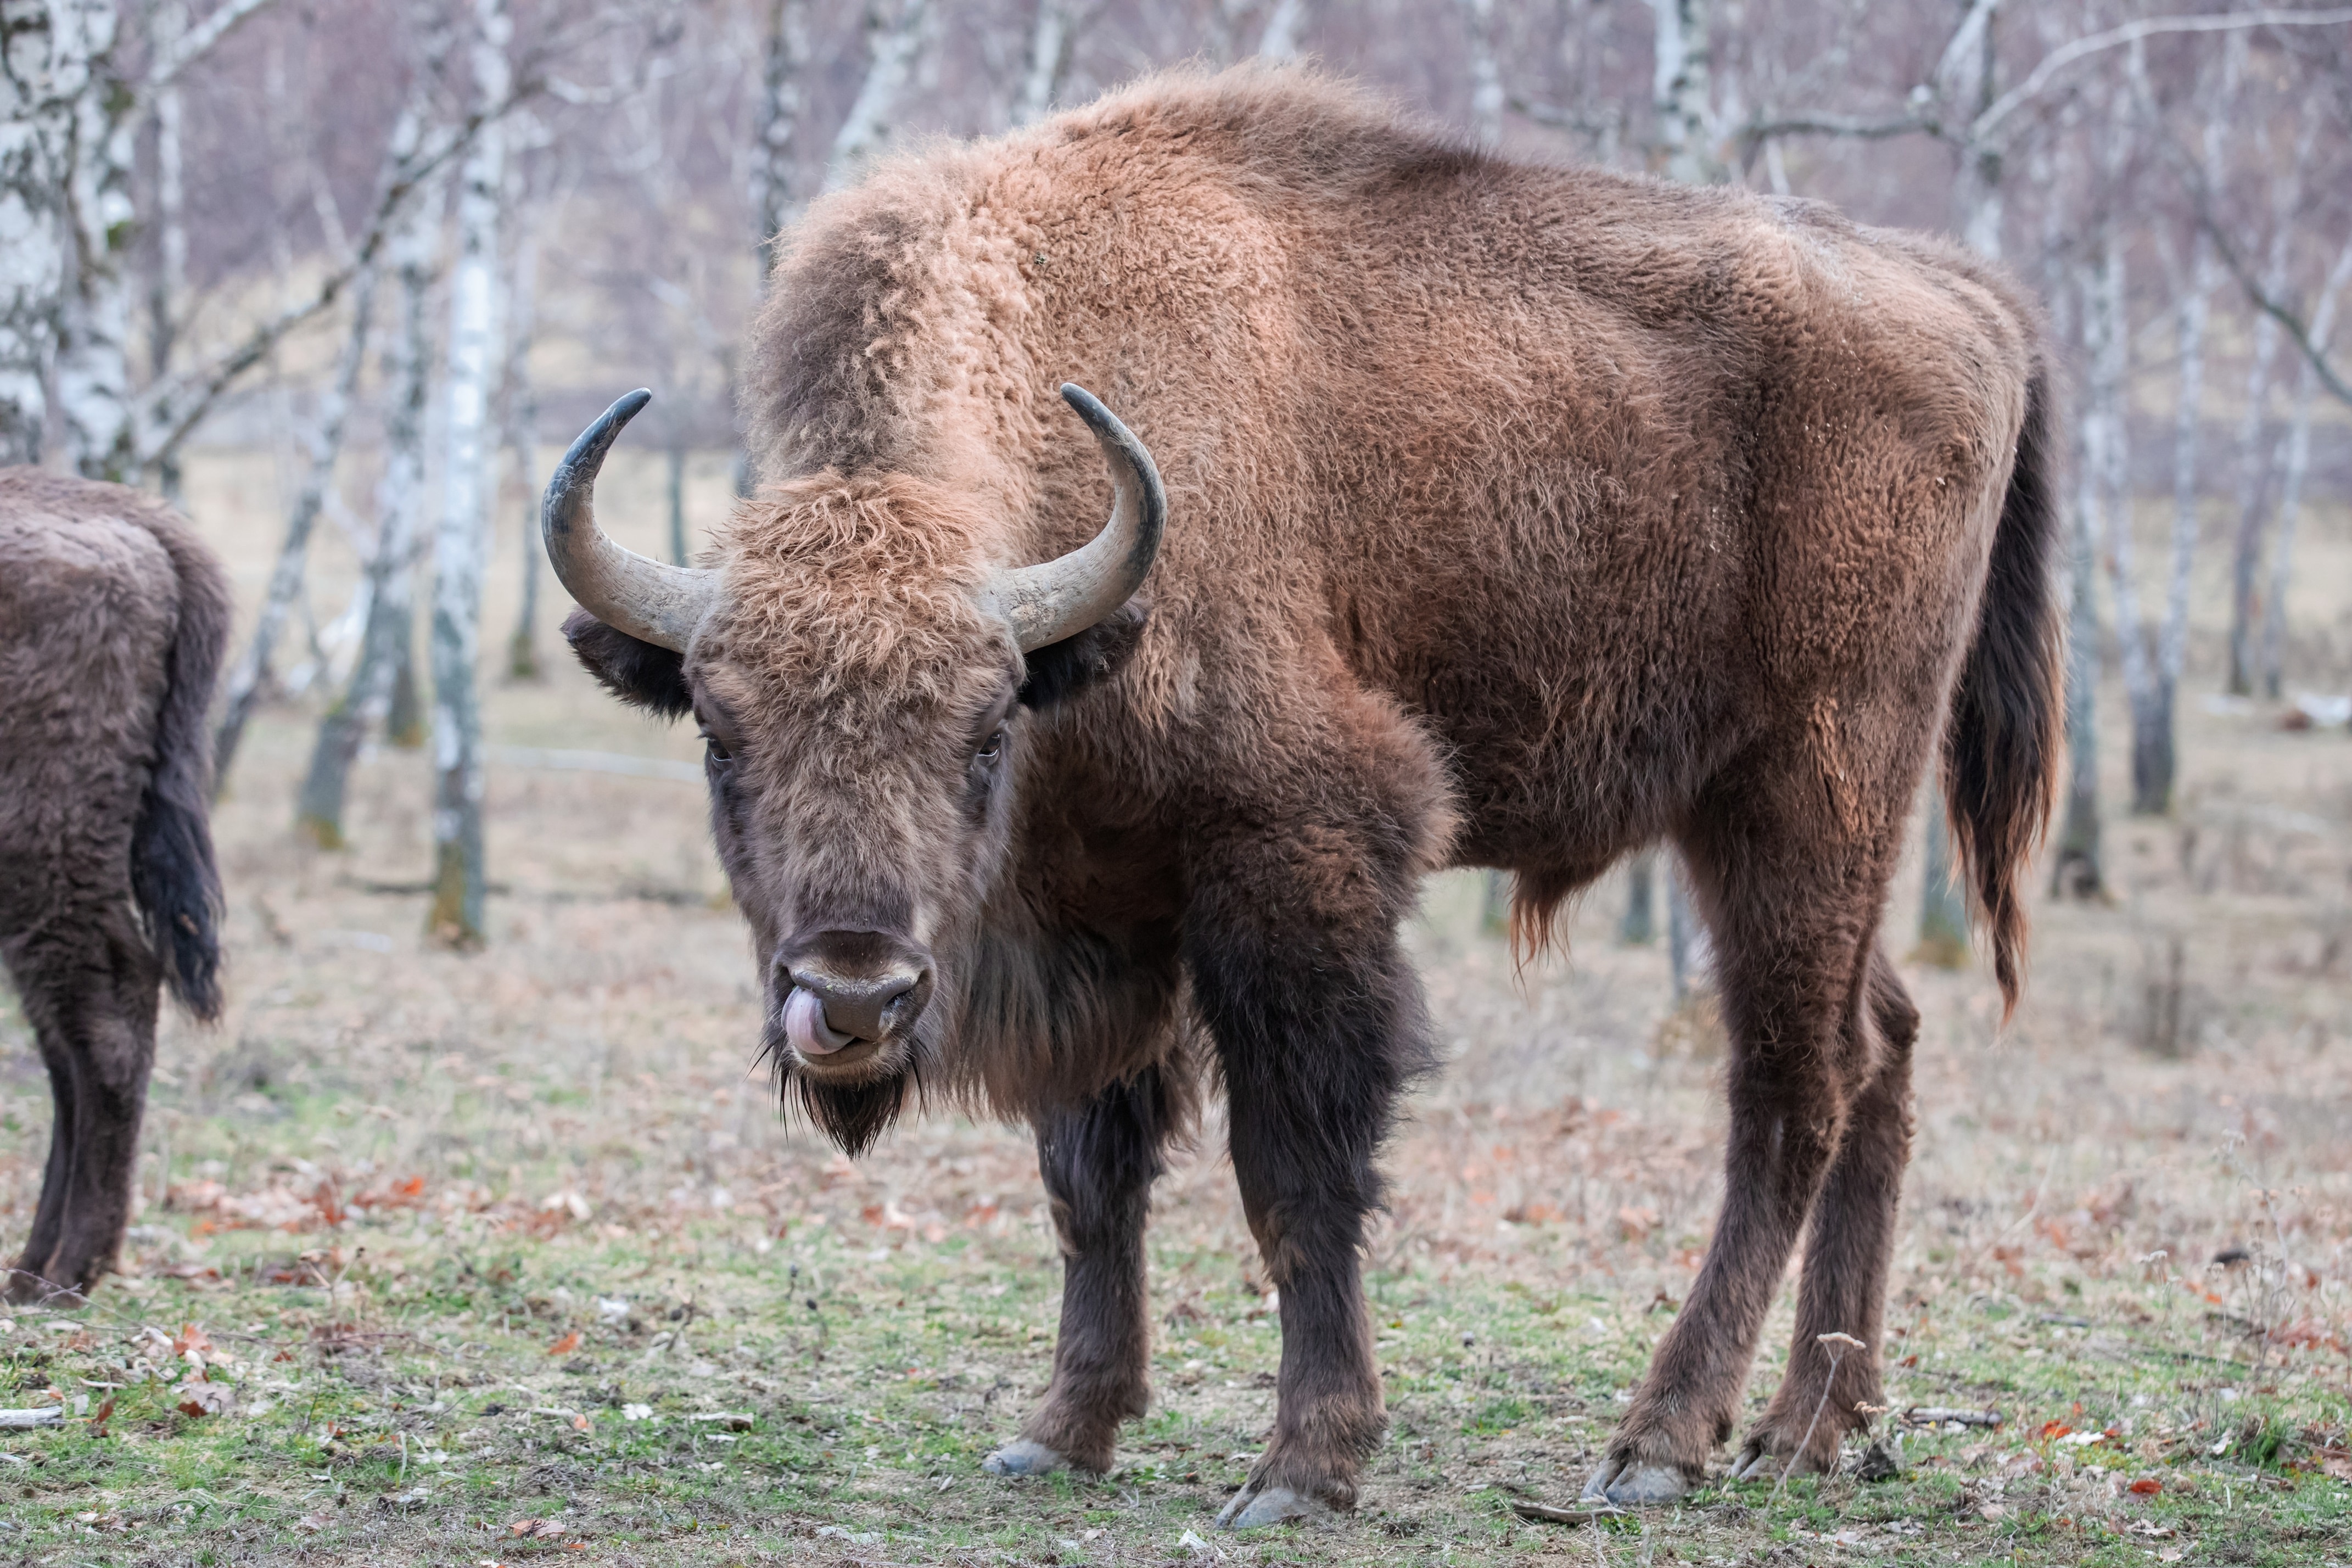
xmin=0 ymin=0 xmax=2352 ymax=949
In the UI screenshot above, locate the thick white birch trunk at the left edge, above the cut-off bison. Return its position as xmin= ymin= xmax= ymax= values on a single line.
xmin=0 ymin=0 xmax=82 ymax=463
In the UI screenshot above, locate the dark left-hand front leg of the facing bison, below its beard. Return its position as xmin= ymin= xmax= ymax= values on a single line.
xmin=985 ymin=1067 xmax=1174 ymax=1476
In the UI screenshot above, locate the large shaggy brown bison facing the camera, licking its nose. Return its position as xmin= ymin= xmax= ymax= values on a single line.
xmin=546 ymin=68 xmax=2058 ymax=1526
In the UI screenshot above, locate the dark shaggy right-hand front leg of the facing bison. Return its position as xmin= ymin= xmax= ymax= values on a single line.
xmin=1192 ymin=879 xmax=1427 ymax=1528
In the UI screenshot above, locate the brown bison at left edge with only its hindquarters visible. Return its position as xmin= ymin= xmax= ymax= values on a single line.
xmin=0 ymin=468 xmax=228 ymax=1300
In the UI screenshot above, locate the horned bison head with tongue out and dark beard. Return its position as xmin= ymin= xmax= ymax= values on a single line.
xmin=544 ymin=385 xmax=1167 ymax=1152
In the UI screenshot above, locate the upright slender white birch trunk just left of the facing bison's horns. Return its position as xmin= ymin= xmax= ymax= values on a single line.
xmin=425 ymin=0 xmax=515 ymax=948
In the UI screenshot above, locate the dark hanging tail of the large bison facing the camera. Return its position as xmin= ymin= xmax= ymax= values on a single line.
xmin=1943 ymin=365 xmax=2065 ymax=1020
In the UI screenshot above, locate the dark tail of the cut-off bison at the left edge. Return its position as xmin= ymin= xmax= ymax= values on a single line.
xmin=132 ymin=519 xmax=231 ymax=1023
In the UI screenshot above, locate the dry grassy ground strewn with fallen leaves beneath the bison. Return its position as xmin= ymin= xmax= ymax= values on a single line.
xmin=0 ymin=451 xmax=2352 ymax=1566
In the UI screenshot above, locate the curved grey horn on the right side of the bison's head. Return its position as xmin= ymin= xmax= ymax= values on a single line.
xmin=981 ymin=381 xmax=1169 ymax=653
